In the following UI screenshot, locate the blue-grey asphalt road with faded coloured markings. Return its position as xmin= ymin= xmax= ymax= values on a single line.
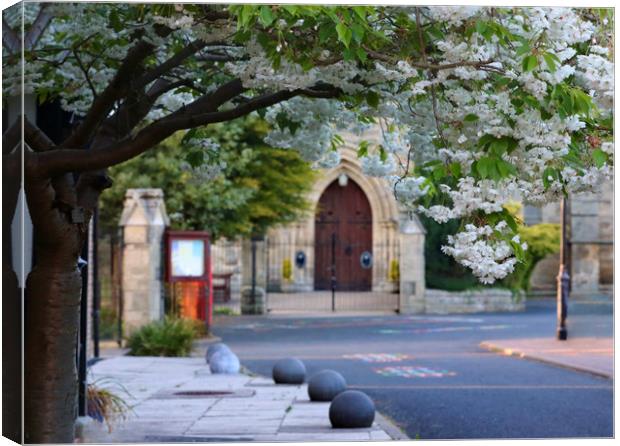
xmin=209 ymin=302 xmax=613 ymax=439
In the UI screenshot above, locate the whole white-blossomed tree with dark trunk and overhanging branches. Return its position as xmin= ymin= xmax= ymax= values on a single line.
xmin=3 ymin=3 xmax=613 ymax=442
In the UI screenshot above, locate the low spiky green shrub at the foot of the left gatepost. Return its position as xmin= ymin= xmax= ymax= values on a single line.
xmin=127 ymin=317 xmax=198 ymax=356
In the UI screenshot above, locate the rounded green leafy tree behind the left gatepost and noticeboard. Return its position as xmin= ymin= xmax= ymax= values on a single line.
xmin=101 ymin=118 xmax=315 ymax=240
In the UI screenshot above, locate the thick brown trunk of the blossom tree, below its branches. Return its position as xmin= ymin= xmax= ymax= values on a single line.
xmin=24 ymin=167 xmax=90 ymax=443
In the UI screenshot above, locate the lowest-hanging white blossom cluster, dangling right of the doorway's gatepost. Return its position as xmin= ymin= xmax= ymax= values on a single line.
xmin=441 ymin=222 xmax=527 ymax=284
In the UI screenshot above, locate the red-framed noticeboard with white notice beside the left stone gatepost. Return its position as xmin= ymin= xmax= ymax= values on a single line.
xmin=165 ymin=230 xmax=213 ymax=327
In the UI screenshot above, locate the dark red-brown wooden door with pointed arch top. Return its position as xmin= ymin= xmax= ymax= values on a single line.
xmin=314 ymin=179 xmax=372 ymax=291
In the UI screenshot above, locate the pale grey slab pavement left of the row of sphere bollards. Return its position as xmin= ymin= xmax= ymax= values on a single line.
xmin=81 ymin=356 xmax=406 ymax=443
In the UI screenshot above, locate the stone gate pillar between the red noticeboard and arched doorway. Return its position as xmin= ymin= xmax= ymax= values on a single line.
xmin=241 ymin=238 xmax=269 ymax=314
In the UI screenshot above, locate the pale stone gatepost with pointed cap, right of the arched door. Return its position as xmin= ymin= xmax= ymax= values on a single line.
xmin=398 ymin=214 xmax=426 ymax=314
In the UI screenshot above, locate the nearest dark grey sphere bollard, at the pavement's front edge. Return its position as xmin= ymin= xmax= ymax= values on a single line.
xmin=329 ymin=390 xmax=375 ymax=428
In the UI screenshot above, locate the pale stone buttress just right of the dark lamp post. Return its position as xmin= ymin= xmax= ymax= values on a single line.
xmin=570 ymin=194 xmax=599 ymax=298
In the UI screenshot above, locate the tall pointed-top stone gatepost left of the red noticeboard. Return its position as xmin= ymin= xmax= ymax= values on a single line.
xmin=119 ymin=189 xmax=170 ymax=336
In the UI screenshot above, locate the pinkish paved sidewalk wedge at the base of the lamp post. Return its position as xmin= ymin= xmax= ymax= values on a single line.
xmin=480 ymin=337 xmax=614 ymax=379
